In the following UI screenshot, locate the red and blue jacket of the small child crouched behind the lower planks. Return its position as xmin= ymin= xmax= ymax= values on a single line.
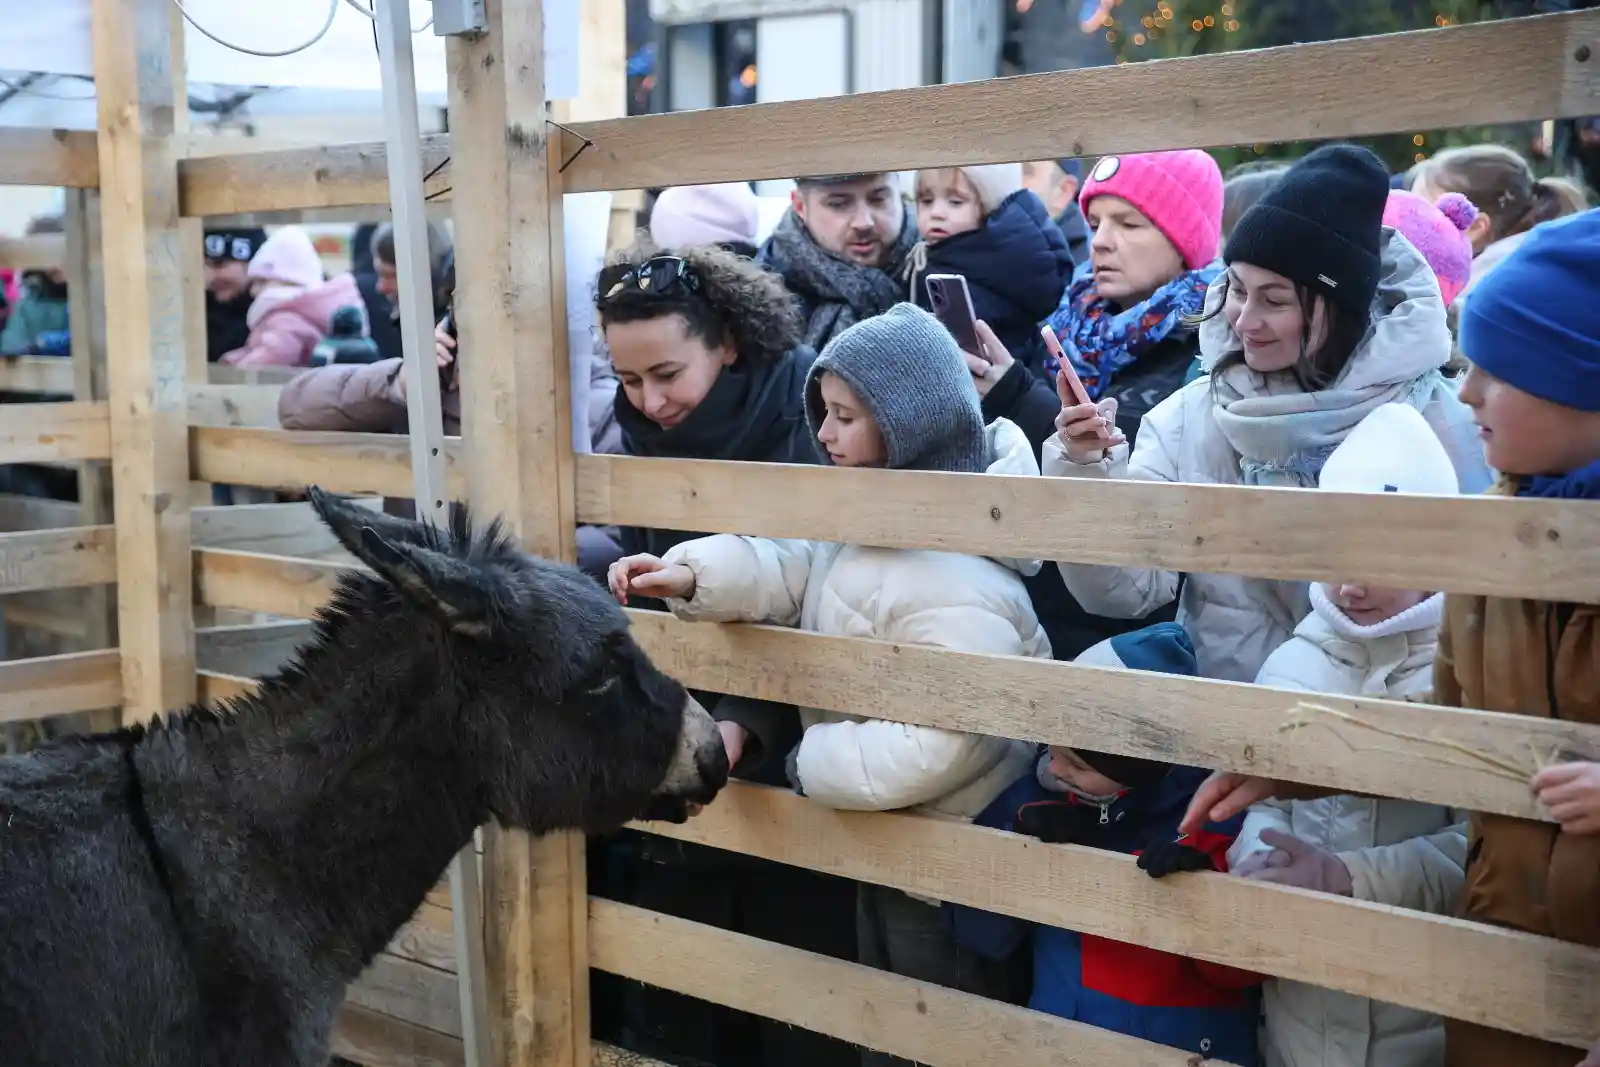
xmin=946 ymin=766 xmax=1264 ymax=1067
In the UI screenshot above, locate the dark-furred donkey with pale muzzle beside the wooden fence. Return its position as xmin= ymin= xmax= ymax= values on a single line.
xmin=0 ymin=490 xmax=728 ymax=1067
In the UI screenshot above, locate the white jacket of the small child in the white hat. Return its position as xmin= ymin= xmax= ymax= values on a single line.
xmin=1229 ymin=585 xmax=1467 ymax=1067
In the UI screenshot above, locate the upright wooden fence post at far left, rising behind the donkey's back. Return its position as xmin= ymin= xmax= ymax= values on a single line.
xmin=91 ymin=0 xmax=195 ymax=720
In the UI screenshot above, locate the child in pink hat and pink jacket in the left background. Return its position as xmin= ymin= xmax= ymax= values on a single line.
xmin=221 ymin=226 xmax=366 ymax=366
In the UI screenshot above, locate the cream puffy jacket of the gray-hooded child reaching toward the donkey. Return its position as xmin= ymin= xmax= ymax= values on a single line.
xmin=664 ymin=419 xmax=1050 ymax=817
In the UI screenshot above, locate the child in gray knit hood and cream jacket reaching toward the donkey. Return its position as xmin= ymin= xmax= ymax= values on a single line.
xmin=610 ymin=304 xmax=1050 ymax=1017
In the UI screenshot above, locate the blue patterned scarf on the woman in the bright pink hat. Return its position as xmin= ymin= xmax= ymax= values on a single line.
xmin=1045 ymin=261 xmax=1222 ymax=400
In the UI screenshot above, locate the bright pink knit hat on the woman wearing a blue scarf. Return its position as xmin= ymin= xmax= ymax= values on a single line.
xmin=1078 ymin=149 xmax=1222 ymax=270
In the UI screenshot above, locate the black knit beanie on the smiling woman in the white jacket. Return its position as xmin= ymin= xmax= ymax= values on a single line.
xmin=1222 ymin=144 xmax=1389 ymax=315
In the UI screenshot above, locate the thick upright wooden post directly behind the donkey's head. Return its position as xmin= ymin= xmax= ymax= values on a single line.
xmin=448 ymin=0 xmax=589 ymax=1067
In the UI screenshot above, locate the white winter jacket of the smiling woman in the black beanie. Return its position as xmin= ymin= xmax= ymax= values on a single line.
xmin=1043 ymin=230 xmax=1490 ymax=681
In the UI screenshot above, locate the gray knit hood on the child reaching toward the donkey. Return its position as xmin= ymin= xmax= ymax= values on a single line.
xmin=805 ymin=304 xmax=990 ymax=474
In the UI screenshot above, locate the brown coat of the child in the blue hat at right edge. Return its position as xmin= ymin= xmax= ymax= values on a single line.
xmin=1434 ymin=485 xmax=1600 ymax=1067
